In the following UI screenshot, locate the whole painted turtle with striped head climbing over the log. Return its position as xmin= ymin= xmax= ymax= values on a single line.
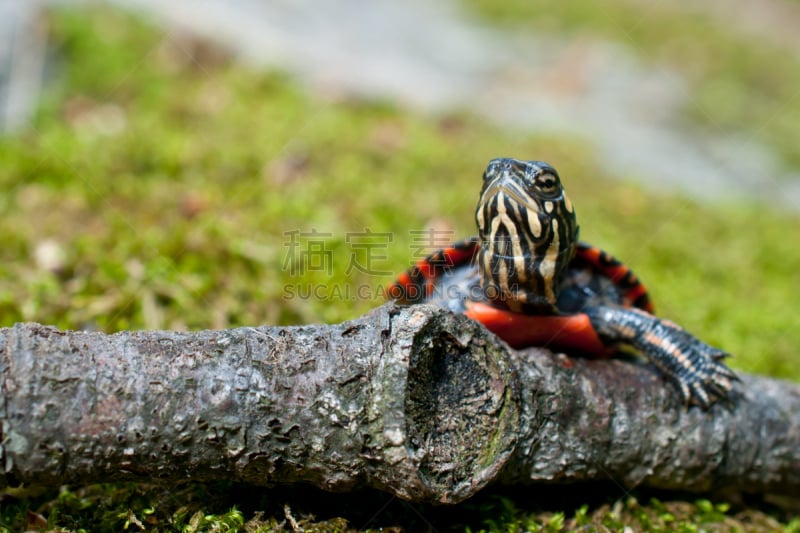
xmin=386 ymin=157 xmax=738 ymax=409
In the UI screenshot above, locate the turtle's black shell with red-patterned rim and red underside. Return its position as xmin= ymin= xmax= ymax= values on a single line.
xmin=387 ymin=237 xmax=653 ymax=356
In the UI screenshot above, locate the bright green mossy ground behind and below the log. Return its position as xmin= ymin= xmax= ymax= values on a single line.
xmin=0 ymin=5 xmax=800 ymax=531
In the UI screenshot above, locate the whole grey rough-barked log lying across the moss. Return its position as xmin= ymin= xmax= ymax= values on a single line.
xmin=0 ymin=304 xmax=800 ymax=503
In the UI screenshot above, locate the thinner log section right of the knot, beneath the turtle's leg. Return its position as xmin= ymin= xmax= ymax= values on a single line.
xmin=499 ymin=349 xmax=800 ymax=497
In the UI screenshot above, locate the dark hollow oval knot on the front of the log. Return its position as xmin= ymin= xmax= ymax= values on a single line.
xmin=406 ymin=312 xmax=517 ymax=498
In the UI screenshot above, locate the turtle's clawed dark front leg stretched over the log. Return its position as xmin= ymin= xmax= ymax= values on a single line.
xmin=583 ymin=305 xmax=738 ymax=409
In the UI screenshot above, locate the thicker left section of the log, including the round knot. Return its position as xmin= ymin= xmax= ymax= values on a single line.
xmin=0 ymin=305 xmax=519 ymax=502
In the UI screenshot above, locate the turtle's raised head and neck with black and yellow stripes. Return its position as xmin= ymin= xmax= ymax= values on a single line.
xmin=475 ymin=158 xmax=578 ymax=313
